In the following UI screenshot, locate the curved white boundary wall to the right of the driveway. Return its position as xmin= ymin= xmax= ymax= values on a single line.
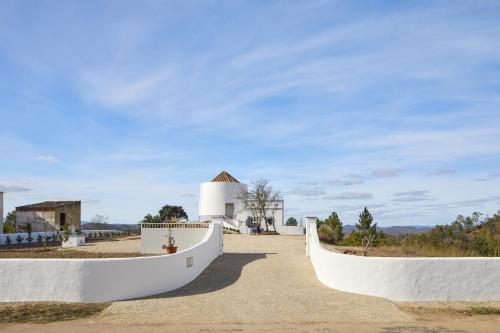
xmin=306 ymin=218 xmax=500 ymax=301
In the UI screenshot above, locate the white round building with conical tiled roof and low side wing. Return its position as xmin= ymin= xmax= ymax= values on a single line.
xmin=199 ymin=171 xmax=303 ymax=234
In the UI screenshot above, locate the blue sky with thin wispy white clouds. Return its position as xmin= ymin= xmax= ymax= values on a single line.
xmin=0 ymin=1 xmax=500 ymax=225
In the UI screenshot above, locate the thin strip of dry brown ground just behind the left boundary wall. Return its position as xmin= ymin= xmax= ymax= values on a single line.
xmin=0 ymin=245 xmax=147 ymax=259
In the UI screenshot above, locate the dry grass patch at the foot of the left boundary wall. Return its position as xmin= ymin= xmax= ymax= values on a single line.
xmin=0 ymin=302 xmax=111 ymax=323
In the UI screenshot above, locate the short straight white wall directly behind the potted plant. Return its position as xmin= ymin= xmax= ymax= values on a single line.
xmin=141 ymin=224 xmax=208 ymax=253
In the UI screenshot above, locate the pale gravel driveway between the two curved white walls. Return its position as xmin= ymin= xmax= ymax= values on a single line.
xmin=102 ymin=234 xmax=412 ymax=324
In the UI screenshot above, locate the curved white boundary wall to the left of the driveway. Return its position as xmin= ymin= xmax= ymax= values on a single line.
xmin=0 ymin=223 xmax=223 ymax=303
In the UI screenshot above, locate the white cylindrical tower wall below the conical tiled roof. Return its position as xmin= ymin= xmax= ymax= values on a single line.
xmin=199 ymin=182 xmax=248 ymax=216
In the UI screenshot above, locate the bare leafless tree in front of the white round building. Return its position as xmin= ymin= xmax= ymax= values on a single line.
xmin=239 ymin=179 xmax=281 ymax=232
